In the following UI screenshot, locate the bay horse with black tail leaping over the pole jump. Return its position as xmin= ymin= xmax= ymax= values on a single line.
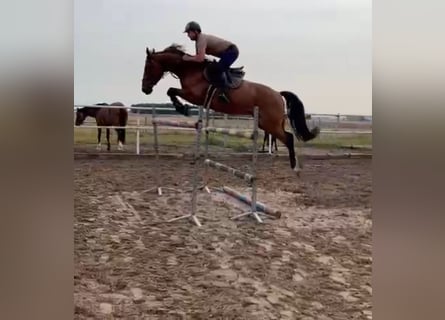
xmin=142 ymin=45 xmax=319 ymax=172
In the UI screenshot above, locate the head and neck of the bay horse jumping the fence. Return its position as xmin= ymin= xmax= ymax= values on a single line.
xmin=142 ymin=45 xmax=185 ymax=94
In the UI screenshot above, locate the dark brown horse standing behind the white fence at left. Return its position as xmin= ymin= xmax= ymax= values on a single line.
xmin=76 ymin=102 xmax=128 ymax=151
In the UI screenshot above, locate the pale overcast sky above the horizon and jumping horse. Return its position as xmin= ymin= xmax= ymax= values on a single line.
xmin=74 ymin=0 xmax=372 ymax=115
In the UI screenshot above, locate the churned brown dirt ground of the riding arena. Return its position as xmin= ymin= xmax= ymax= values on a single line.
xmin=74 ymin=157 xmax=372 ymax=320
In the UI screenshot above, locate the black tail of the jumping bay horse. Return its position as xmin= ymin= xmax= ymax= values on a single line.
xmin=280 ymin=91 xmax=320 ymax=142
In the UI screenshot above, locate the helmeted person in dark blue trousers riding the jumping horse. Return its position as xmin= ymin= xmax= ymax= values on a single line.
xmin=184 ymin=21 xmax=239 ymax=103
